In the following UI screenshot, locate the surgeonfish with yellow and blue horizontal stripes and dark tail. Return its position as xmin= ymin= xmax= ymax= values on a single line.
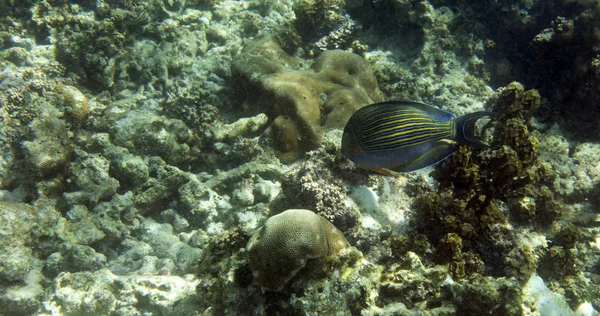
xmin=342 ymin=101 xmax=493 ymax=174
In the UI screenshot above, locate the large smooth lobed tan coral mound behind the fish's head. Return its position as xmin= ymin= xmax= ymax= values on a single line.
xmin=232 ymin=38 xmax=381 ymax=162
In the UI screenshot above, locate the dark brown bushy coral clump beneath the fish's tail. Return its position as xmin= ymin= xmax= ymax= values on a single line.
xmin=413 ymin=83 xmax=564 ymax=278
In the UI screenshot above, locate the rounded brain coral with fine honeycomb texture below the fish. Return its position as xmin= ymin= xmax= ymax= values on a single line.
xmin=246 ymin=209 xmax=348 ymax=291
